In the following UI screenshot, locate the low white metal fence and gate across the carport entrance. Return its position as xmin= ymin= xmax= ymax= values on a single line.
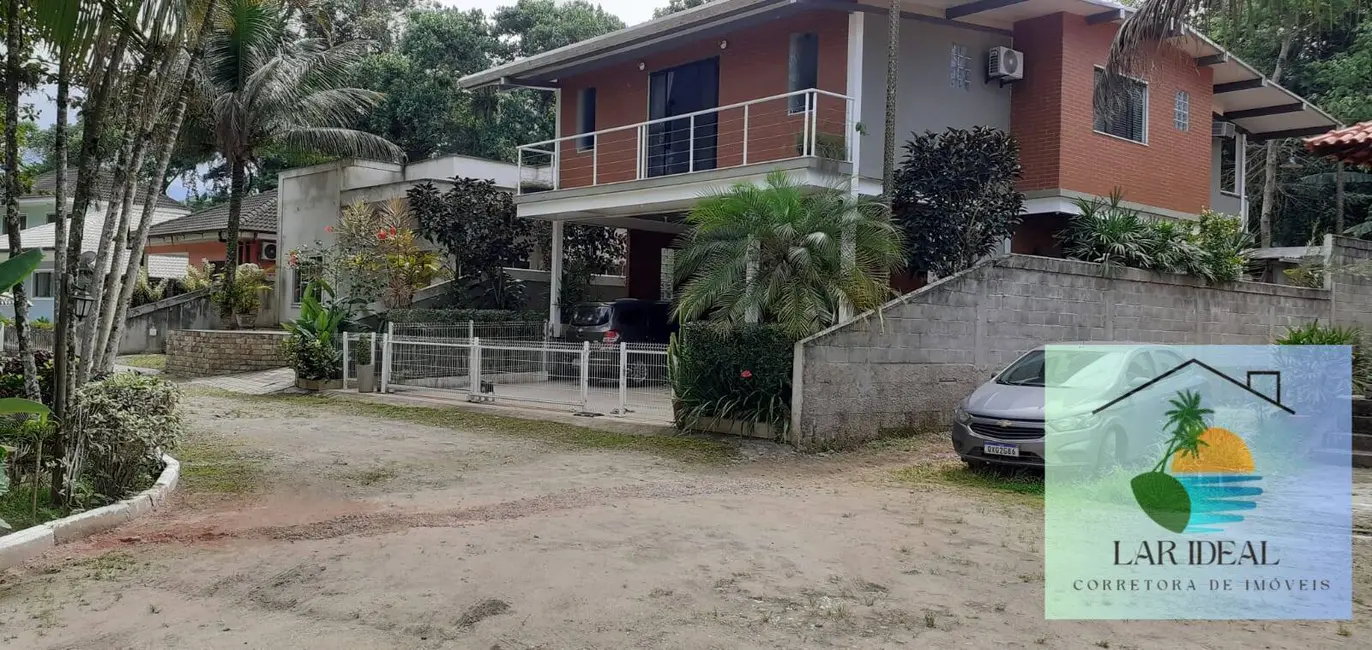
xmin=343 ymin=322 xmax=672 ymax=422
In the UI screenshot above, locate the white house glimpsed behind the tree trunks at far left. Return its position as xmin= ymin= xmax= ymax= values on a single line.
xmin=0 ymin=169 xmax=189 ymax=320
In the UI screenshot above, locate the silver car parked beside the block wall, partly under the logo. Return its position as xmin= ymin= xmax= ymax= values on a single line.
xmin=952 ymin=343 xmax=1194 ymax=468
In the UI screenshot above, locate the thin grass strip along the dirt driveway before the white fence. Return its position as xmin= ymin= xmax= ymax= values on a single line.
xmin=198 ymin=391 xmax=737 ymax=464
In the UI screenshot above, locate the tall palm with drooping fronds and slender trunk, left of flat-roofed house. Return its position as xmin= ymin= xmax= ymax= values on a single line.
xmin=198 ymin=0 xmax=402 ymax=292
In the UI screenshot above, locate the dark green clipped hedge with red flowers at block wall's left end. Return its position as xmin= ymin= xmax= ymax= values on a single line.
xmin=668 ymin=322 xmax=796 ymax=432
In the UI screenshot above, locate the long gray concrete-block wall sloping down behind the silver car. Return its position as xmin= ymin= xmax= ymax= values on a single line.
xmin=790 ymin=245 xmax=1372 ymax=448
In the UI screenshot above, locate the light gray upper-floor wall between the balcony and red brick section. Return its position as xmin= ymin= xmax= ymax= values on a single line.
xmin=859 ymin=14 xmax=1011 ymax=178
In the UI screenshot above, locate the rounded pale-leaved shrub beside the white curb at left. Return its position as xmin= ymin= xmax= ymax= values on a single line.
xmin=77 ymin=373 xmax=185 ymax=502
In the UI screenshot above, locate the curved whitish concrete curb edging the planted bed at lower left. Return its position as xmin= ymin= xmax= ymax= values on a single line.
xmin=0 ymin=454 xmax=181 ymax=570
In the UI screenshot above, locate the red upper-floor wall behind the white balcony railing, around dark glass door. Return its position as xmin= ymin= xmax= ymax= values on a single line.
xmin=560 ymin=11 xmax=848 ymax=188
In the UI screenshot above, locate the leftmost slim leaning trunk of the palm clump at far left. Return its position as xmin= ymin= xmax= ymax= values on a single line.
xmin=52 ymin=24 xmax=129 ymax=506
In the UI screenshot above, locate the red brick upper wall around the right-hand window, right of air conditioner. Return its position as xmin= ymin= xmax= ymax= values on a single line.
xmin=1010 ymin=14 xmax=1213 ymax=213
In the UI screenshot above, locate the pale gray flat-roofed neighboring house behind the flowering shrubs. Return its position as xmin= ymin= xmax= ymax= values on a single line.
xmin=275 ymin=155 xmax=576 ymax=320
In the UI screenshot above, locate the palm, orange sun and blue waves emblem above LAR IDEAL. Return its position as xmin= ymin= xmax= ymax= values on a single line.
xmin=1129 ymin=391 xmax=1262 ymax=533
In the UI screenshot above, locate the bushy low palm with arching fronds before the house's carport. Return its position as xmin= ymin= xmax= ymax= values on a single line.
xmin=676 ymin=173 xmax=901 ymax=337
